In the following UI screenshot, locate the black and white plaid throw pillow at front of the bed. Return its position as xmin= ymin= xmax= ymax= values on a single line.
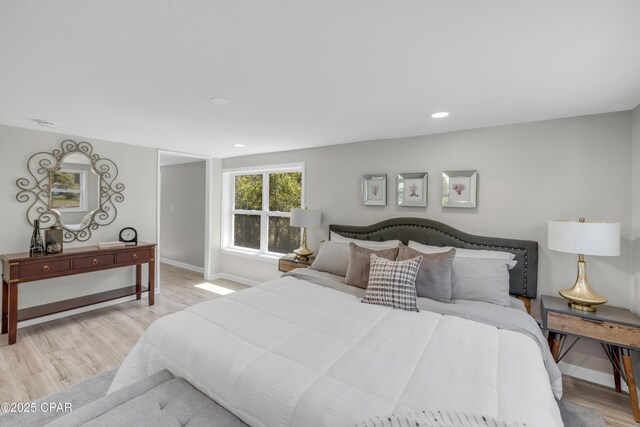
xmin=362 ymin=254 xmax=422 ymax=311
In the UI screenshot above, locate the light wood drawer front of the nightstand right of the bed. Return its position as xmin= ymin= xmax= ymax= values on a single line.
xmin=547 ymin=311 xmax=640 ymax=347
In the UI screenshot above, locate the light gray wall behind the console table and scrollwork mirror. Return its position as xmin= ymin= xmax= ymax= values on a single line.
xmin=0 ymin=126 xmax=157 ymax=308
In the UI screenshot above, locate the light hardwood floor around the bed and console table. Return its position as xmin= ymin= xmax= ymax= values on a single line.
xmin=0 ymin=264 xmax=640 ymax=426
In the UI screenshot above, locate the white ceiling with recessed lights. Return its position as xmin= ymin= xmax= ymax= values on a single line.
xmin=0 ymin=0 xmax=640 ymax=157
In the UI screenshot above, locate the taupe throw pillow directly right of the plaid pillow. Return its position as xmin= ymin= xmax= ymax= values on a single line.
xmin=396 ymin=244 xmax=456 ymax=302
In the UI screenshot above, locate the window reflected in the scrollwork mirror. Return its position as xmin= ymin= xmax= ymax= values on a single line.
xmin=50 ymin=169 xmax=87 ymax=212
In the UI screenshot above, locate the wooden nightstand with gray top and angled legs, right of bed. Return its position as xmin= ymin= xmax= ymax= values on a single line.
xmin=541 ymin=295 xmax=640 ymax=422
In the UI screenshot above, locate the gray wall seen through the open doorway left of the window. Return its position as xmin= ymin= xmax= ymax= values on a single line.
xmin=160 ymin=160 xmax=206 ymax=268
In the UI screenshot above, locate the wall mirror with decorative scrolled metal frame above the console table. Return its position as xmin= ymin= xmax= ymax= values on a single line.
xmin=16 ymin=139 xmax=124 ymax=242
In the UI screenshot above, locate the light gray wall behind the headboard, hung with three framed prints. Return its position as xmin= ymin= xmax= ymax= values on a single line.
xmin=222 ymin=112 xmax=632 ymax=382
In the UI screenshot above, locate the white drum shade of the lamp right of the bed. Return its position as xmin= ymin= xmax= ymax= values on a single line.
xmin=548 ymin=220 xmax=620 ymax=256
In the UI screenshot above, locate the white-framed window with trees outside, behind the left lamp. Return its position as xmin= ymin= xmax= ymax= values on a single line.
xmin=225 ymin=165 xmax=303 ymax=255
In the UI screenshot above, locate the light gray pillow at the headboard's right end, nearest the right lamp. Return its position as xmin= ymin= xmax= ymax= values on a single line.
xmin=451 ymin=257 xmax=516 ymax=307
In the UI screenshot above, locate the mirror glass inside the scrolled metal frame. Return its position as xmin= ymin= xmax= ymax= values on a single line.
xmin=49 ymin=152 xmax=100 ymax=231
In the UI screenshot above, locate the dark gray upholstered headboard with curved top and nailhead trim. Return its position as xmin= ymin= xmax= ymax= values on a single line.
xmin=329 ymin=218 xmax=538 ymax=298
